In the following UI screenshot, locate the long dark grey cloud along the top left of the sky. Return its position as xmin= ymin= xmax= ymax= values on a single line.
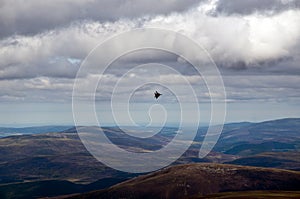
xmin=0 ymin=0 xmax=199 ymax=38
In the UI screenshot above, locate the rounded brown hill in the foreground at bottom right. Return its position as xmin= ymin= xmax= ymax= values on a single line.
xmin=69 ymin=163 xmax=300 ymax=199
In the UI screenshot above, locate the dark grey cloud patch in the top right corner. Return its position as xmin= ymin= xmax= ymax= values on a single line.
xmin=216 ymin=0 xmax=300 ymax=15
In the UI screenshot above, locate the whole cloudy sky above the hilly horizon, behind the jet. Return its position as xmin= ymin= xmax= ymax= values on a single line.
xmin=0 ymin=0 xmax=300 ymax=126
